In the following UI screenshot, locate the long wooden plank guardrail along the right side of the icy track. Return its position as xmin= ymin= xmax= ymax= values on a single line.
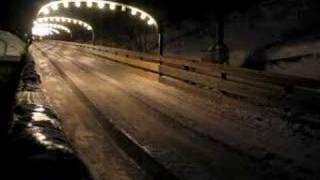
xmin=53 ymin=41 xmax=320 ymax=107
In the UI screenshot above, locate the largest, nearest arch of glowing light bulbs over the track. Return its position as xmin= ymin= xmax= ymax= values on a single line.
xmin=38 ymin=0 xmax=158 ymax=28
